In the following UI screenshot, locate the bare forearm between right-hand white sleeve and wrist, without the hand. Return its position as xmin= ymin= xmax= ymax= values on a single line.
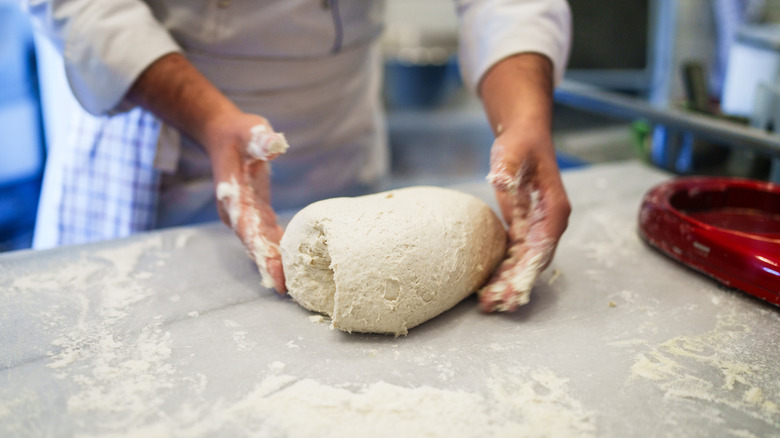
xmin=479 ymin=53 xmax=553 ymax=140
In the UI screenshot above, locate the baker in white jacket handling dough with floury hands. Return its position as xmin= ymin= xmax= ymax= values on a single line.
xmin=23 ymin=0 xmax=571 ymax=311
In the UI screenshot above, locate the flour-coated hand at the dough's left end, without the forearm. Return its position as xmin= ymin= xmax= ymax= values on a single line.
xmin=205 ymin=112 xmax=287 ymax=293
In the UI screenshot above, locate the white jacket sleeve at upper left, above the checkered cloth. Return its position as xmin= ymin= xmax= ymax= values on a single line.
xmin=22 ymin=0 xmax=181 ymax=115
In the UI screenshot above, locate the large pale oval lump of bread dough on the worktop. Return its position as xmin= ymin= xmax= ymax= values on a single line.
xmin=281 ymin=187 xmax=506 ymax=335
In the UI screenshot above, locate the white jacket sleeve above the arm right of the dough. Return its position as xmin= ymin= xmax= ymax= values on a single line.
xmin=456 ymin=0 xmax=571 ymax=95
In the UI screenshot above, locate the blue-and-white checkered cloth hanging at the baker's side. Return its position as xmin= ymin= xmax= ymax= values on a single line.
xmin=36 ymin=108 xmax=161 ymax=246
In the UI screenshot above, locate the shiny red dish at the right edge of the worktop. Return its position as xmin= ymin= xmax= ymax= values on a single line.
xmin=639 ymin=177 xmax=780 ymax=306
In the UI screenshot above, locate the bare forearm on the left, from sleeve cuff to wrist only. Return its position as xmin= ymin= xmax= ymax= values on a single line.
xmin=127 ymin=53 xmax=240 ymax=154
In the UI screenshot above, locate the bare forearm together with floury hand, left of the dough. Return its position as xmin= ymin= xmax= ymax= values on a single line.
xmin=126 ymin=53 xmax=287 ymax=293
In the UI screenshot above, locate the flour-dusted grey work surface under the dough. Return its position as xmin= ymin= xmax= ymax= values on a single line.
xmin=0 ymin=163 xmax=780 ymax=437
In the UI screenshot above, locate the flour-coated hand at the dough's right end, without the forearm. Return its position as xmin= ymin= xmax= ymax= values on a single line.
xmin=478 ymin=130 xmax=571 ymax=312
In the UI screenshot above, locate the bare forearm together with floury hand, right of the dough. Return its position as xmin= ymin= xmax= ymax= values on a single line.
xmin=479 ymin=54 xmax=571 ymax=312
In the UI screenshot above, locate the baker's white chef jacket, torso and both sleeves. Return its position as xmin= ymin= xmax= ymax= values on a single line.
xmin=23 ymin=0 xmax=570 ymax=246
